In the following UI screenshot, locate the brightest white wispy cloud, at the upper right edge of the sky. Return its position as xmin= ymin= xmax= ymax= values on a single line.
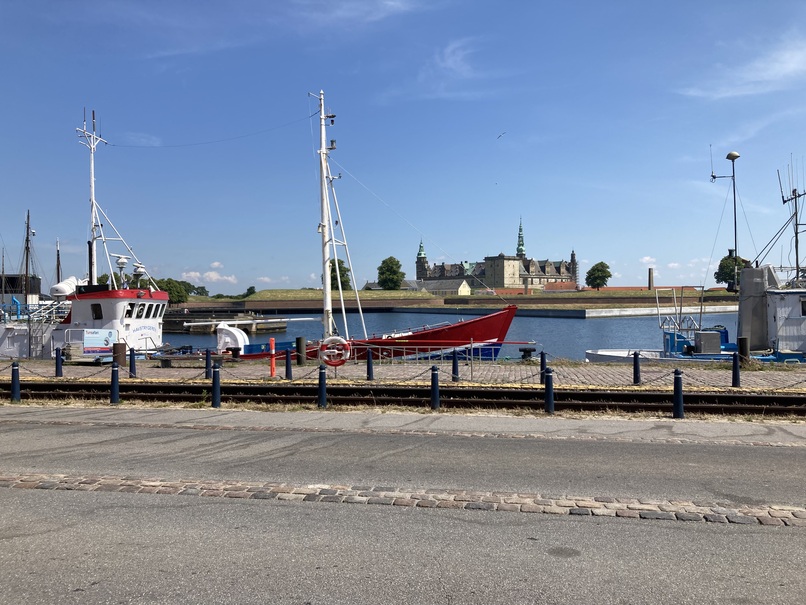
xmin=680 ymin=36 xmax=806 ymax=100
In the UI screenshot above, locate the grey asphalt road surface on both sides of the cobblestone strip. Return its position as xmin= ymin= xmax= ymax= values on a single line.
xmin=0 ymin=406 xmax=806 ymax=604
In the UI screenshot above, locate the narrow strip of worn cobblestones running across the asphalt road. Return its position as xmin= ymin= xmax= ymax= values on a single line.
xmin=0 ymin=473 xmax=806 ymax=527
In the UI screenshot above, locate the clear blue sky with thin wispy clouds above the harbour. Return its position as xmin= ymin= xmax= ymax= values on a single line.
xmin=0 ymin=0 xmax=806 ymax=293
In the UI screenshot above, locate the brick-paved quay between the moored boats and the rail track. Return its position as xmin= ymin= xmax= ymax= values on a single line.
xmin=0 ymin=359 xmax=806 ymax=394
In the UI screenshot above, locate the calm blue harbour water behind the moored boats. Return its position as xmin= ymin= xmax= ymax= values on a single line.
xmin=163 ymin=313 xmax=736 ymax=359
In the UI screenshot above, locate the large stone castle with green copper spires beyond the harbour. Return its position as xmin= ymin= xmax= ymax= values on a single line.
xmin=416 ymin=221 xmax=579 ymax=293
